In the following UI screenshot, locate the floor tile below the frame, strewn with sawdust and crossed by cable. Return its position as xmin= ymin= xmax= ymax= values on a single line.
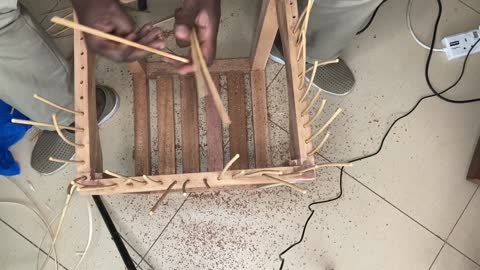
xmin=138 ymin=161 xmax=442 ymax=269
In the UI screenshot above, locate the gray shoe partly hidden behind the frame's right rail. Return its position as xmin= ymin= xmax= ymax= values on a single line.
xmin=270 ymin=35 xmax=355 ymax=96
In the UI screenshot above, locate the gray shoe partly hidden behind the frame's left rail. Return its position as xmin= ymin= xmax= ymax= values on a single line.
xmin=30 ymin=85 xmax=120 ymax=175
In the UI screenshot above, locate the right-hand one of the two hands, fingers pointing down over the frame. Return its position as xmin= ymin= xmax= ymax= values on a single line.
xmin=175 ymin=0 xmax=221 ymax=74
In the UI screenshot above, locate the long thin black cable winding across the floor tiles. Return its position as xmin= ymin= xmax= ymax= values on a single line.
xmin=279 ymin=0 xmax=480 ymax=270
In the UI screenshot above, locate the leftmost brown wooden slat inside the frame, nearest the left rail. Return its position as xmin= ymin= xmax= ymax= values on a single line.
xmin=132 ymin=61 xmax=150 ymax=175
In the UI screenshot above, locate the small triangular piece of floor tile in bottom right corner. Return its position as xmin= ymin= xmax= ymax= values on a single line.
xmin=430 ymin=245 xmax=480 ymax=270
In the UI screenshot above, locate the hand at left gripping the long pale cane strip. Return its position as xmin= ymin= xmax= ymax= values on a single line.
xmin=72 ymin=0 xmax=165 ymax=62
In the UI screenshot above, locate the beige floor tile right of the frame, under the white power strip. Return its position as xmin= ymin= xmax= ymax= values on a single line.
xmin=292 ymin=0 xmax=480 ymax=238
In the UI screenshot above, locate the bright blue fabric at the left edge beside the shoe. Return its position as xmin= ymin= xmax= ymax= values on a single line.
xmin=0 ymin=99 xmax=30 ymax=176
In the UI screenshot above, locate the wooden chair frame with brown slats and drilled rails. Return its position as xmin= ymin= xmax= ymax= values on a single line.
xmin=74 ymin=0 xmax=322 ymax=195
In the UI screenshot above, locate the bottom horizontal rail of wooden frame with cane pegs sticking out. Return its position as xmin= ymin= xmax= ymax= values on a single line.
xmin=79 ymin=166 xmax=315 ymax=195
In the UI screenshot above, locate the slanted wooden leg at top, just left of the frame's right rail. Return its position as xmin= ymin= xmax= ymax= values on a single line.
xmin=251 ymin=0 xmax=278 ymax=72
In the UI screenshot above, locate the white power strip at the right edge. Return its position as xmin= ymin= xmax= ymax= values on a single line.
xmin=442 ymin=29 xmax=480 ymax=61
